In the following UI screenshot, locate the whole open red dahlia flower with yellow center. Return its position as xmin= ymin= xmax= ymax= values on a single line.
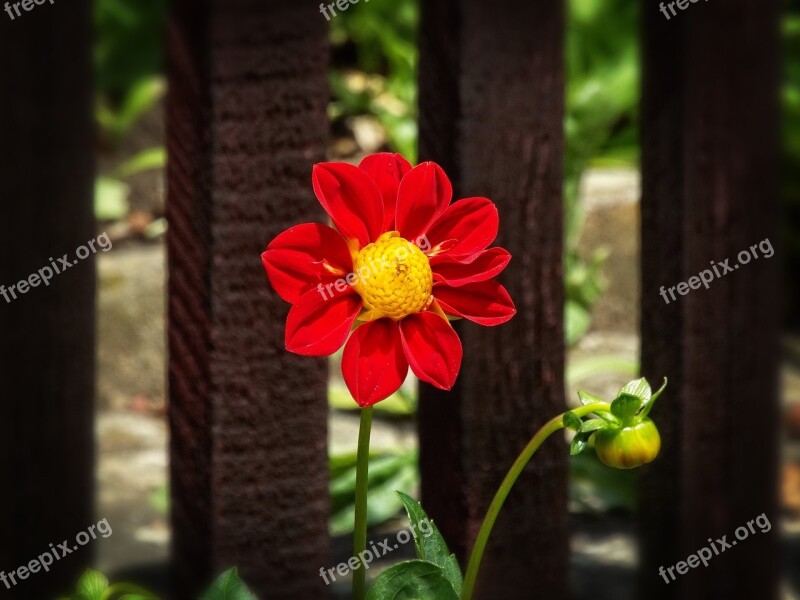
xmin=261 ymin=153 xmax=516 ymax=407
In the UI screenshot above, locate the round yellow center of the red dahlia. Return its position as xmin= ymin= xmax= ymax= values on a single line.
xmin=353 ymin=231 xmax=433 ymax=321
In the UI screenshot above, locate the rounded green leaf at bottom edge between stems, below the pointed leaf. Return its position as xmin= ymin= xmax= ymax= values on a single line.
xmin=367 ymin=560 xmax=458 ymax=600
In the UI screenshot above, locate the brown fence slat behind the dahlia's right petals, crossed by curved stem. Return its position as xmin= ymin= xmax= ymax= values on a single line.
xmin=419 ymin=0 xmax=568 ymax=600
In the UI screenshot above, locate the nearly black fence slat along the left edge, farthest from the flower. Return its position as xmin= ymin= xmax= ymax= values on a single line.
xmin=0 ymin=0 xmax=96 ymax=599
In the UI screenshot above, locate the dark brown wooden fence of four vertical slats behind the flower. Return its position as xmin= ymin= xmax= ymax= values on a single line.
xmin=0 ymin=0 xmax=779 ymax=600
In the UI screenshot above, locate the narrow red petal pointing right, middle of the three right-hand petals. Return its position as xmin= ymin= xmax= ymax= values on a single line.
xmin=433 ymin=279 xmax=517 ymax=325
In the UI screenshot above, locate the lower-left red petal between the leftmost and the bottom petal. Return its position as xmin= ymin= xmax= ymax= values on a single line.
xmin=286 ymin=289 xmax=361 ymax=356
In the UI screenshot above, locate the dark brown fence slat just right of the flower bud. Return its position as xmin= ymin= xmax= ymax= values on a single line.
xmin=639 ymin=0 xmax=781 ymax=600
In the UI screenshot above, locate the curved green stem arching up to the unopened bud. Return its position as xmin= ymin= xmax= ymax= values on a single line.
xmin=461 ymin=402 xmax=611 ymax=600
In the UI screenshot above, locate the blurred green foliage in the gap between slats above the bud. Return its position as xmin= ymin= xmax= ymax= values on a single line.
xmin=564 ymin=0 xmax=639 ymax=345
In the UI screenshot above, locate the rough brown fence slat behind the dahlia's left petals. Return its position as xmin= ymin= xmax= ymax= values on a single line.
xmin=167 ymin=0 xmax=329 ymax=599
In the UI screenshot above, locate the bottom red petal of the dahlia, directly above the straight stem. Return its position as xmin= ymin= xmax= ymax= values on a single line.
xmin=342 ymin=319 xmax=408 ymax=408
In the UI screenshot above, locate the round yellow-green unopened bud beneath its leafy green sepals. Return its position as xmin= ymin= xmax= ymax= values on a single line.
xmin=594 ymin=417 xmax=661 ymax=469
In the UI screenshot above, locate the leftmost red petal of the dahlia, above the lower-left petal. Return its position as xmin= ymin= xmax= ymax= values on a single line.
xmin=261 ymin=223 xmax=353 ymax=304
